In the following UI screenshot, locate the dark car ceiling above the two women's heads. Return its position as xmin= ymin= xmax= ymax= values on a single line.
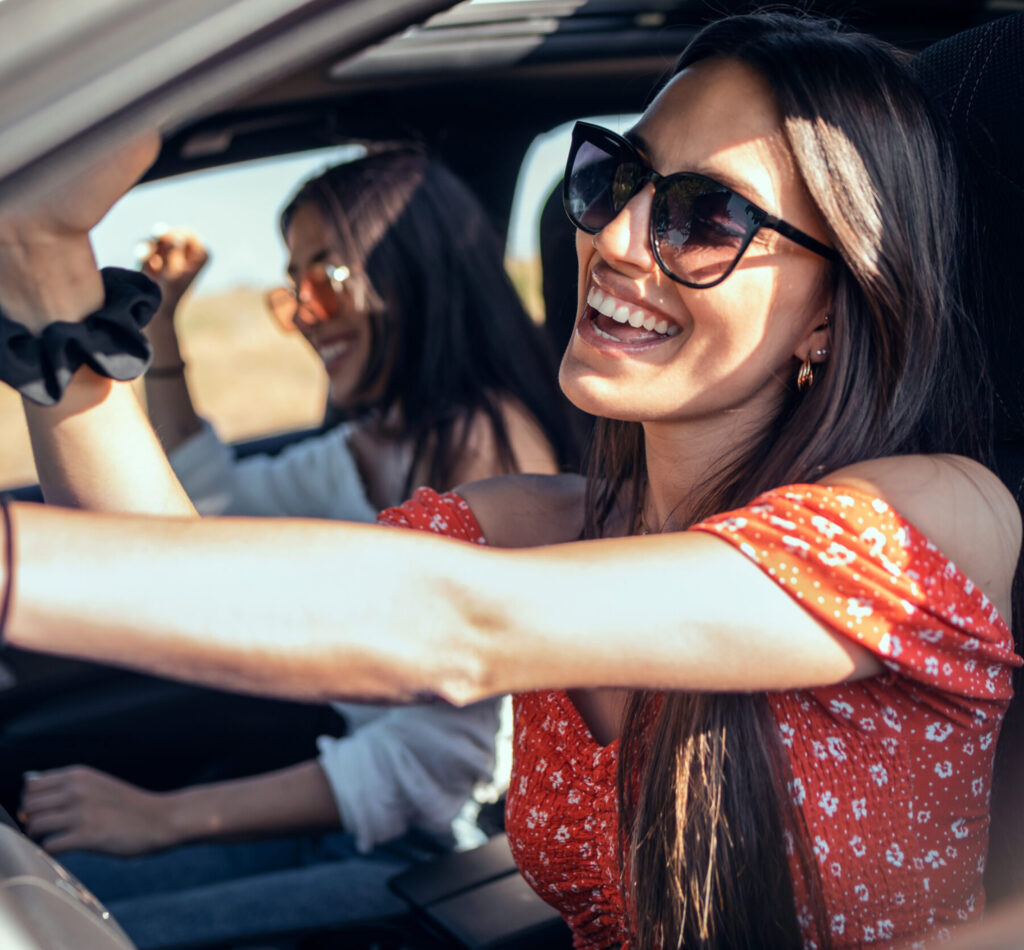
xmin=153 ymin=0 xmax=1024 ymax=230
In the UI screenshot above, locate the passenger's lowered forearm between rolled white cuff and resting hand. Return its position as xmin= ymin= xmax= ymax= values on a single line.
xmin=164 ymin=761 xmax=340 ymax=844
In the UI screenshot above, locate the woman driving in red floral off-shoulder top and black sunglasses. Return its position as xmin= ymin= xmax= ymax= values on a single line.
xmin=0 ymin=9 xmax=1020 ymax=948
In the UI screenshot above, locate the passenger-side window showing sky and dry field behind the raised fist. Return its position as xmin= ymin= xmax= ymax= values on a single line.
xmin=0 ymin=146 xmax=361 ymax=489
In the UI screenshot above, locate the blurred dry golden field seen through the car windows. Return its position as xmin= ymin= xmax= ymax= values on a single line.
xmin=0 ymin=260 xmax=543 ymax=489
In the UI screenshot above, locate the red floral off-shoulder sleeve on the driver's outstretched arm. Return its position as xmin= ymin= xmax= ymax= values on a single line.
xmin=693 ymin=485 xmax=1021 ymax=701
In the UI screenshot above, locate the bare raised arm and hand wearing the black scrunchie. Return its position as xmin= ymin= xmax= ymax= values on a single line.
xmin=0 ymin=136 xmax=194 ymax=515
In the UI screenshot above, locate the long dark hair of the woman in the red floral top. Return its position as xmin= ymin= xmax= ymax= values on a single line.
xmin=585 ymin=13 xmax=989 ymax=950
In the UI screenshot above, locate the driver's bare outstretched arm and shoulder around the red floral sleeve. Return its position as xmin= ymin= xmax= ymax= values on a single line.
xmin=2 ymin=459 xmax=1007 ymax=704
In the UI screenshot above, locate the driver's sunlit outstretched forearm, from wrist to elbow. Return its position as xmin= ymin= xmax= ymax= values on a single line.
xmin=6 ymin=505 xmax=481 ymax=703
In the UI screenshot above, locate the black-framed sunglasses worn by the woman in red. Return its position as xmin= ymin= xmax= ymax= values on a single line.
xmin=562 ymin=122 xmax=839 ymax=288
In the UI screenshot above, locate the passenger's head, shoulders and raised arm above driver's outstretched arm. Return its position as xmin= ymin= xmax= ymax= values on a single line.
xmin=144 ymin=146 xmax=572 ymax=520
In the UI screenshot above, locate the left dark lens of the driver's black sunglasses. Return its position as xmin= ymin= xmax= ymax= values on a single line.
xmin=565 ymin=133 xmax=643 ymax=234
